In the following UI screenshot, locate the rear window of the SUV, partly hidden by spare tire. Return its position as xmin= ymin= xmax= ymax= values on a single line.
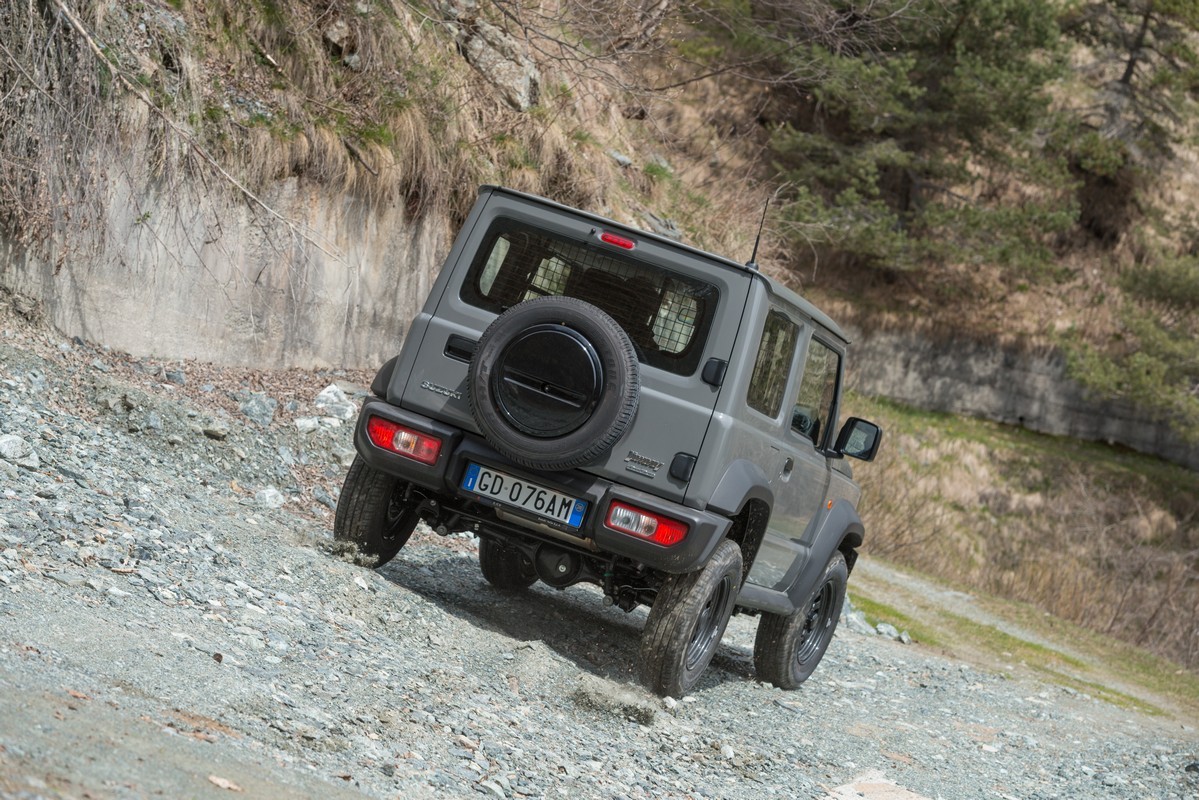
xmin=462 ymin=219 xmax=718 ymax=374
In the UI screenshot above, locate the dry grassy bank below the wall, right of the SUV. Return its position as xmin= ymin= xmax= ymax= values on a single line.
xmin=855 ymin=401 xmax=1199 ymax=670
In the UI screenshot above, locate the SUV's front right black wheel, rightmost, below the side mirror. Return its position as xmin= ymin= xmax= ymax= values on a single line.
xmin=753 ymin=552 xmax=849 ymax=690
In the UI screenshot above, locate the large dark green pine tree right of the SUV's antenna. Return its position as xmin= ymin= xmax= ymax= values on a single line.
xmin=775 ymin=0 xmax=1074 ymax=269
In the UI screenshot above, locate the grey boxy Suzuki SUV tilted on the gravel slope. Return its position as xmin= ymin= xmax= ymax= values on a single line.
xmin=333 ymin=186 xmax=882 ymax=697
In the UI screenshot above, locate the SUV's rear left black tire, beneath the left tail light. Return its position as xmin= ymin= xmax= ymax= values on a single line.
xmin=333 ymin=456 xmax=420 ymax=566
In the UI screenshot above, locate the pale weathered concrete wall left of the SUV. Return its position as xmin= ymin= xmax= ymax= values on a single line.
xmin=0 ymin=170 xmax=452 ymax=367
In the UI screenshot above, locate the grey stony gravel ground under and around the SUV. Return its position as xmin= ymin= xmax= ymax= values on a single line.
xmin=0 ymin=297 xmax=1199 ymax=800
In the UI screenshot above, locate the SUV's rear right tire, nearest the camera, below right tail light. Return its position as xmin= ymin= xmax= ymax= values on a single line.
xmin=639 ymin=540 xmax=741 ymax=697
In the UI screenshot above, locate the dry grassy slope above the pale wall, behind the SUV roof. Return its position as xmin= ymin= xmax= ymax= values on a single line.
xmin=0 ymin=0 xmax=785 ymax=266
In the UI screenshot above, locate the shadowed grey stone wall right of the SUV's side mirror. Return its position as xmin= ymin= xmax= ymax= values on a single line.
xmin=849 ymin=331 xmax=1199 ymax=469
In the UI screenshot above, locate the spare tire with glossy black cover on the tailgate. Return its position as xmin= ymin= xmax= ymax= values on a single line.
xmin=469 ymin=296 xmax=641 ymax=470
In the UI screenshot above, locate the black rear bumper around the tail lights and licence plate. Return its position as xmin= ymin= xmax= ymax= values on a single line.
xmin=354 ymin=398 xmax=730 ymax=573
